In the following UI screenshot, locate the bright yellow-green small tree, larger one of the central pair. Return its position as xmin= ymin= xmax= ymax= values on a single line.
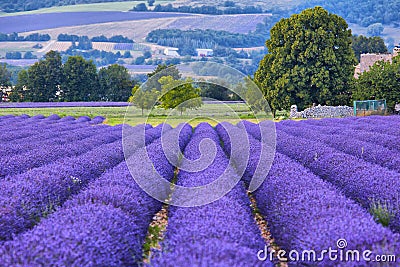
xmin=159 ymin=76 xmax=203 ymax=115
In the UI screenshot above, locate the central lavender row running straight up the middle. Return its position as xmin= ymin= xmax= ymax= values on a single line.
xmin=149 ymin=124 xmax=272 ymax=266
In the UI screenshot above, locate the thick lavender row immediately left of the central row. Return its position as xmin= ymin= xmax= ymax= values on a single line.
xmin=0 ymin=125 xmax=191 ymax=266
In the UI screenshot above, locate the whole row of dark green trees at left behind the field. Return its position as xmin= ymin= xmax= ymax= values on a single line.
xmin=10 ymin=51 xmax=136 ymax=102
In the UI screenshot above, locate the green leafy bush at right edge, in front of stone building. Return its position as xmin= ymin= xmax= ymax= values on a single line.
xmin=353 ymin=57 xmax=400 ymax=110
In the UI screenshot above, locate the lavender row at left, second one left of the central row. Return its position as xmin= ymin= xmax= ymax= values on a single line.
xmin=0 ymin=125 xmax=166 ymax=240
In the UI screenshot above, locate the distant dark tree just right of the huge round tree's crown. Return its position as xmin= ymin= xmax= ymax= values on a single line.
xmin=351 ymin=35 xmax=388 ymax=61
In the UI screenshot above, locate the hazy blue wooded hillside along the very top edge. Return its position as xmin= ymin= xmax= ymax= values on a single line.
xmin=0 ymin=0 xmax=400 ymax=27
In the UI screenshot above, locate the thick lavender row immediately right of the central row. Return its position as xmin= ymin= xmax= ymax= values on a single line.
xmin=222 ymin=122 xmax=400 ymax=266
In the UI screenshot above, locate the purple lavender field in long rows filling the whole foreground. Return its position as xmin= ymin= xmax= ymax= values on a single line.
xmin=0 ymin=115 xmax=400 ymax=266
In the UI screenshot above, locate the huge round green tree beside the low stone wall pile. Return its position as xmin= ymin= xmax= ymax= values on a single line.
xmin=255 ymin=7 xmax=356 ymax=111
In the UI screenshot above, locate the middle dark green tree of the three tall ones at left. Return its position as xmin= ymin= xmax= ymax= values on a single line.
xmin=61 ymin=56 xmax=100 ymax=101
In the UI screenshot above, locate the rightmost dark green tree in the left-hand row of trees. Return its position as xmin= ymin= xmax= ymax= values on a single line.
xmin=98 ymin=64 xmax=134 ymax=101
